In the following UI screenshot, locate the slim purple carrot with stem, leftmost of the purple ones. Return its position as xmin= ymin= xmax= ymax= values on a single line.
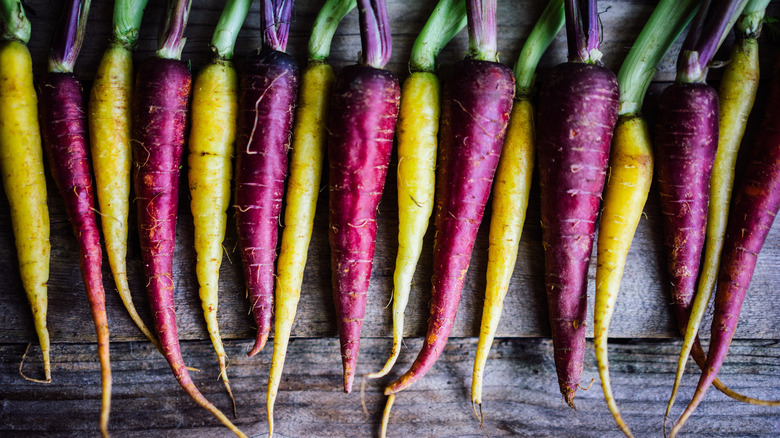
xmin=40 ymin=0 xmax=111 ymax=436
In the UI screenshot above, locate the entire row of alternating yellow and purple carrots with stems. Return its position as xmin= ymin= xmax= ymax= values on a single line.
xmin=0 ymin=0 xmax=780 ymax=436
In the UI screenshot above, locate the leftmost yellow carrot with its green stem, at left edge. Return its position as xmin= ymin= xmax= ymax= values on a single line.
xmin=0 ymin=0 xmax=51 ymax=383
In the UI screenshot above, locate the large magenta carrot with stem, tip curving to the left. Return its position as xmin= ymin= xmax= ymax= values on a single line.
xmin=385 ymin=0 xmax=515 ymax=395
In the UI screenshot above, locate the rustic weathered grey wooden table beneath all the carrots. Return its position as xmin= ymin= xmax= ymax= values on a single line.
xmin=0 ymin=0 xmax=780 ymax=437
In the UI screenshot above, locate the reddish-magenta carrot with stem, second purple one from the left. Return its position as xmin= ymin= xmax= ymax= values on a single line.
xmin=132 ymin=0 xmax=245 ymax=436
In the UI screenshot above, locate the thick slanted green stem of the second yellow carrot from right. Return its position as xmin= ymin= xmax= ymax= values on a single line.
xmin=618 ymin=0 xmax=699 ymax=115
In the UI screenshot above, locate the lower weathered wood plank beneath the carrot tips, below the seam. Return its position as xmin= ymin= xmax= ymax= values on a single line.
xmin=0 ymin=339 xmax=780 ymax=437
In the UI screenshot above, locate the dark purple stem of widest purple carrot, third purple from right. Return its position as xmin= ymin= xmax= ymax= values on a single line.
xmin=564 ymin=0 xmax=601 ymax=64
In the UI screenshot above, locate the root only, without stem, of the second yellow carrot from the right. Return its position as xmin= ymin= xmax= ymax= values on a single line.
xmin=593 ymin=114 xmax=653 ymax=436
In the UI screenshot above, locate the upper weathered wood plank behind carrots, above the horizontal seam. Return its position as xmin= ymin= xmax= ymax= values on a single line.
xmin=0 ymin=0 xmax=780 ymax=342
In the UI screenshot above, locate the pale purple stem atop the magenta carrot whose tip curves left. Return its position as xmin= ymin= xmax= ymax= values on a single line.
xmin=466 ymin=0 xmax=498 ymax=62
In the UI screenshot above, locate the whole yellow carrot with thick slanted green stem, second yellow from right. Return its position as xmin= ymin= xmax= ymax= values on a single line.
xmin=593 ymin=0 xmax=698 ymax=436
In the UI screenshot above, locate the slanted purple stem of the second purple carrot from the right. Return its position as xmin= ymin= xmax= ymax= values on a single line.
xmin=677 ymin=0 xmax=747 ymax=83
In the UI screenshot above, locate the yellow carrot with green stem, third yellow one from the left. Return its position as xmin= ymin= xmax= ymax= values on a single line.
xmin=187 ymin=0 xmax=252 ymax=416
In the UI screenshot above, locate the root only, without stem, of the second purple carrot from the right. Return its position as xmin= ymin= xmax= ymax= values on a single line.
xmin=654 ymin=83 xmax=718 ymax=340
